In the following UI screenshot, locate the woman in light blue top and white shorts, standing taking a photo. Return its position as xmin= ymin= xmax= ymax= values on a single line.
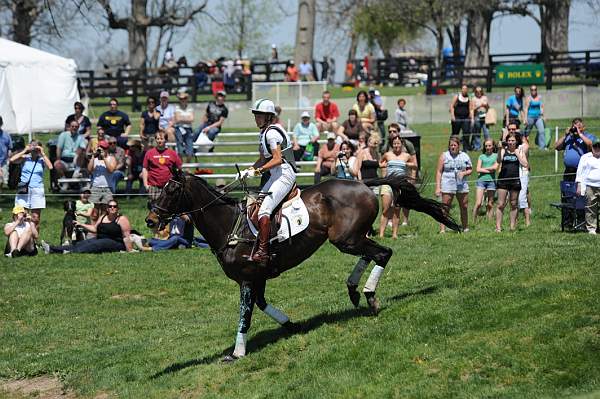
xmin=10 ymin=140 xmax=52 ymax=232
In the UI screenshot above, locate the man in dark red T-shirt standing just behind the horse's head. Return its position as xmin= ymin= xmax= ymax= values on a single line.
xmin=142 ymin=133 xmax=181 ymax=201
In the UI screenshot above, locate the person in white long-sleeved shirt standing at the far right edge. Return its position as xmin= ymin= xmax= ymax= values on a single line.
xmin=575 ymin=138 xmax=600 ymax=234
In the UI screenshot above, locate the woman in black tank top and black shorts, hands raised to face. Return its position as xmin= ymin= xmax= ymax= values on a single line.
xmin=496 ymin=131 xmax=528 ymax=232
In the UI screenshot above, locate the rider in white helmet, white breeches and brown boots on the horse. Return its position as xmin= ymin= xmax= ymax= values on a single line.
xmin=241 ymin=99 xmax=296 ymax=265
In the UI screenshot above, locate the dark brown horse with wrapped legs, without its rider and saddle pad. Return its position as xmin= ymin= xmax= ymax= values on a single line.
xmin=146 ymin=170 xmax=461 ymax=361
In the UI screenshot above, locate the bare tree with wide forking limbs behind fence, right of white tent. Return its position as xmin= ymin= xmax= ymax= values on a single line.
xmin=98 ymin=0 xmax=207 ymax=69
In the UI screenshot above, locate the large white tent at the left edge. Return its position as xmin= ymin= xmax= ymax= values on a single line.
xmin=0 ymin=38 xmax=79 ymax=133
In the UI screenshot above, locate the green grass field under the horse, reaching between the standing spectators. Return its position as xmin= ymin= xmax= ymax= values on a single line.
xmin=0 ymin=121 xmax=600 ymax=398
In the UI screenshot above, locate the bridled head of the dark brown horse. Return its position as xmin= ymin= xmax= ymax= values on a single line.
xmin=146 ymin=168 xmax=185 ymax=230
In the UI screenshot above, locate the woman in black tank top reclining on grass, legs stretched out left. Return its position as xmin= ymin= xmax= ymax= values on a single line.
xmin=42 ymin=200 xmax=132 ymax=254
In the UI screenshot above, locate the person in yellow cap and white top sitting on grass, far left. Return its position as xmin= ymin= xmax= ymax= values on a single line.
xmin=4 ymin=205 xmax=38 ymax=258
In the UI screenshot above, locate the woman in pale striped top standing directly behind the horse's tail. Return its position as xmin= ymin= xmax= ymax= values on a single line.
xmin=379 ymin=136 xmax=417 ymax=239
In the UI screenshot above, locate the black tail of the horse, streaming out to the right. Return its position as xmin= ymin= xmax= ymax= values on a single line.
xmin=364 ymin=175 xmax=462 ymax=231
